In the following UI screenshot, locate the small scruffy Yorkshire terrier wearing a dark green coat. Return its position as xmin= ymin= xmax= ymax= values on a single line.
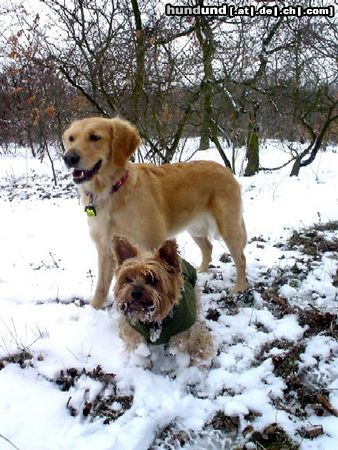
xmin=113 ymin=236 xmax=214 ymax=364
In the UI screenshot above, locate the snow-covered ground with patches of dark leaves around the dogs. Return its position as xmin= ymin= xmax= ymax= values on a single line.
xmin=0 ymin=142 xmax=338 ymax=450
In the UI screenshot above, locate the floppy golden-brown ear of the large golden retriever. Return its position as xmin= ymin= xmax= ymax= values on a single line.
xmin=110 ymin=117 xmax=141 ymax=168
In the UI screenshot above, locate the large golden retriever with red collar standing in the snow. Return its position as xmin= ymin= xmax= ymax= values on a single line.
xmin=63 ymin=117 xmax=246 ymax=308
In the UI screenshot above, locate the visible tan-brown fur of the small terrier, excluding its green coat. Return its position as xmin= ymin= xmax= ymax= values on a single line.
xmin=113 ymin=236 xmax=214 ymax=364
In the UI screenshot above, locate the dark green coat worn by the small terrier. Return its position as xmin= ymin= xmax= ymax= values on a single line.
xmin=130 ymin=259 xmax=197 ymax=345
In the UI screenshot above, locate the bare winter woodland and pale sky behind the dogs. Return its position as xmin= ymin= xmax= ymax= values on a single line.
xmin=0 ymin=0 xmax=338 ymax=182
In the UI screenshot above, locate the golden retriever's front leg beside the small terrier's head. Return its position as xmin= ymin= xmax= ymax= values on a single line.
xmin=90 ymin=248 xmax=115 ymax=309
